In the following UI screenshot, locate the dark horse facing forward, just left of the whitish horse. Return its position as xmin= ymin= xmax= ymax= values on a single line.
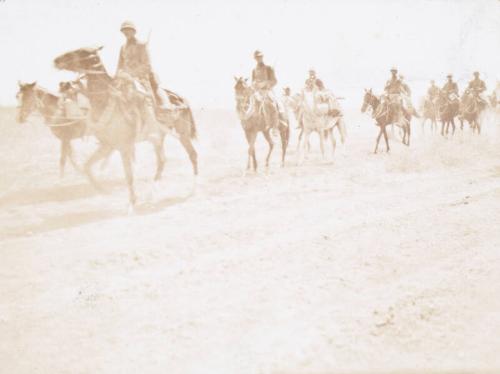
xmin=234 ymin=77 xmax=290 ymax=172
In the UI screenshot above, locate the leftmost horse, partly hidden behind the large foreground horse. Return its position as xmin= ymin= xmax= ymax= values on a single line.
xmin=16 ymin=82 xmax=86 ymax=178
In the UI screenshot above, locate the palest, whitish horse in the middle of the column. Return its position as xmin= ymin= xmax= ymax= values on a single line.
xmin=297 ymin=90 xmax=346 ymax=164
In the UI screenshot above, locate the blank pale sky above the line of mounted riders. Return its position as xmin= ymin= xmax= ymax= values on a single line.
xmin=0 ymin=0 xmax=500 ymax=108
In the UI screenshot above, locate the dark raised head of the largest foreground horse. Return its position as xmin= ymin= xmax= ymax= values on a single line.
xmin=54 ymin=47 xmax=105 ymax=73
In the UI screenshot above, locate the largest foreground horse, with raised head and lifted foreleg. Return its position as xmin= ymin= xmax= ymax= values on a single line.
xmin=54 ymin=47 xmax=198 ymax=207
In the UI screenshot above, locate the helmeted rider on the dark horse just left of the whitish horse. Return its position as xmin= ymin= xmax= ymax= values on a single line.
xmin=252 ymin=51 xmax=284 ymax=134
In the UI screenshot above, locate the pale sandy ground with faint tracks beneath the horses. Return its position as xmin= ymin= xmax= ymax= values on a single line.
xmin=0 ymin=106 xmax=500 ymax=374
